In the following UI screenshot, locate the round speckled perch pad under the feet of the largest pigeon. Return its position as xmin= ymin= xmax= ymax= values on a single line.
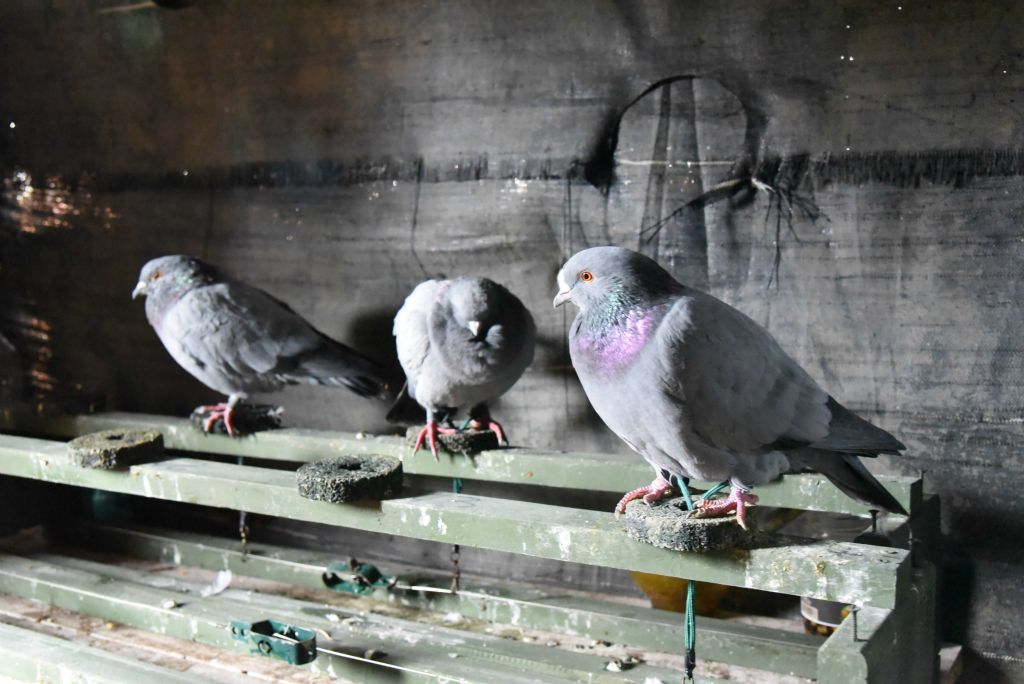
xmin=626 ymin=497 xmax=756 ymax=552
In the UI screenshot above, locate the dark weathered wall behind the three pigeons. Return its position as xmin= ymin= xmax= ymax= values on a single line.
xmin=0 ymin=0 xmax=1024 ymax=676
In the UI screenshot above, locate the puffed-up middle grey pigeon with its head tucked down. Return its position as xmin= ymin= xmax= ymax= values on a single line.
xmin=394 ymin=277 xmax=536 ymax=459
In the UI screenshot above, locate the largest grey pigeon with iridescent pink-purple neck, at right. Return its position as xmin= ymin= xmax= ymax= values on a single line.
xmin=554 ymin=247 xmax=906 ymax=526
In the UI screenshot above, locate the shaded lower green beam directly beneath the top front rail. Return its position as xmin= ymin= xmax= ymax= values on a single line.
xmin=69 ymin=523 xmax=823 ymax=678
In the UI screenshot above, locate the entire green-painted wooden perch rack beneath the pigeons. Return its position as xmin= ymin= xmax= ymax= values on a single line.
xmin=0 ymin=411 xmax=937 ymax=684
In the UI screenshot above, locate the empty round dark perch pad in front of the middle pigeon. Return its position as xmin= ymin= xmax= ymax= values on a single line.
xmin=295 ymin=455 xmax=401 ymax=504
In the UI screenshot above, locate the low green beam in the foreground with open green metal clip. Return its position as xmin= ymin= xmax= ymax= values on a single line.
xmin=0 ymin=554 xmax=696 ymax=684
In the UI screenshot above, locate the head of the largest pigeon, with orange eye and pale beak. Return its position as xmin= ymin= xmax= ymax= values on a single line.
xmin=553 ymin=247 xmax=682 ymax=311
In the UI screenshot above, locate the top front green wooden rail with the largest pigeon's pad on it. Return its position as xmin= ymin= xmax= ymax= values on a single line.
xmin=0 ymin=435 xmax=910 ymax=608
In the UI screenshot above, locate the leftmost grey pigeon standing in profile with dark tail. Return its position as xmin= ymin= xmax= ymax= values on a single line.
xmin=132 ymin=255 xmax=386 ymax=434
